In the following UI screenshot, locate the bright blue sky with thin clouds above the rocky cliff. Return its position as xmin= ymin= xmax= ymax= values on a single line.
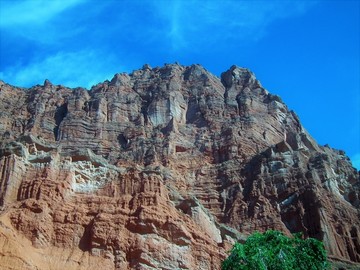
xmin=0 ymin=0 xmax=360 ymax=169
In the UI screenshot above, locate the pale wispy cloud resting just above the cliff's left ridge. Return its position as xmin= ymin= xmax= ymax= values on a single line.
xmin=0 ymin=50 xmax=120 ymax=88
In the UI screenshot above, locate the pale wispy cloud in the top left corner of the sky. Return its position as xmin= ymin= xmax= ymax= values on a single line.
xmin=0 ymin=0 xmax=85 ymax=28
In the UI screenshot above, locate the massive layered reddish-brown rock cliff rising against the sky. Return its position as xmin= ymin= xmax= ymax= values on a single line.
xmin=0 ymin=64 xmax=360 ymax=270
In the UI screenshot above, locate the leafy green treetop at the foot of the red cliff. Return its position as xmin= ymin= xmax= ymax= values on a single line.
xmin=222 ymin=230 xmax=329 ymax=270
